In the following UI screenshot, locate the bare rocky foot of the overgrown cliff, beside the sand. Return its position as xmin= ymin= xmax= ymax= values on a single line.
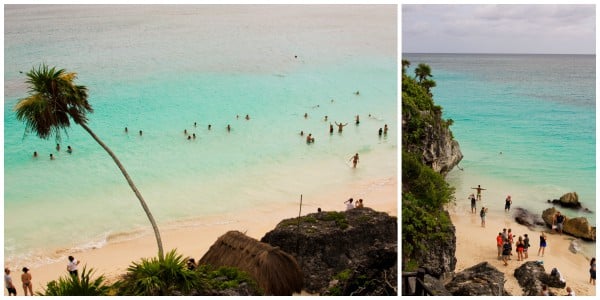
xmin=415 ymin=212 xmax=456 ymax=278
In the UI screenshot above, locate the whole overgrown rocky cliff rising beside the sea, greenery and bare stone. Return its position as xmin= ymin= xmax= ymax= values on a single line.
xmin=402 ymin=60 xmax=463 ymax=284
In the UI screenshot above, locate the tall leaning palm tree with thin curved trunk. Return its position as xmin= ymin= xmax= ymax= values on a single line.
xmin=14 ymin=64 xmax=163 ymax=258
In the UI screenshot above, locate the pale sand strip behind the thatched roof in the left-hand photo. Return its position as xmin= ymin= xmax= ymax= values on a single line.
xmin=5 ymin=176 xmax=398 ymax=295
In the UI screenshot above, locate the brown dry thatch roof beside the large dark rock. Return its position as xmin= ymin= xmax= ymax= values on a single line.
xmin=199 ymin=231 xmax=302 ymax=296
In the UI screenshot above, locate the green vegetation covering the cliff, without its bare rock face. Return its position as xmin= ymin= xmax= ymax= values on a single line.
xmin=402 ymin=60 xmax=454 ymax=270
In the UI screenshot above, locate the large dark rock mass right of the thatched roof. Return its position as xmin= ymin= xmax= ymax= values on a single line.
xmin=261 ymin=208 xmax=398 ymax=295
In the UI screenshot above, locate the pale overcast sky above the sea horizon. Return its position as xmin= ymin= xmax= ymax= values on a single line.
xmin=402 ymin=4 xmax=596 ymax=54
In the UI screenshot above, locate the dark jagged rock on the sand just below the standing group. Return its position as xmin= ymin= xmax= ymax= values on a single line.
xmin=515 ymin=261 xmax=567 ymax=296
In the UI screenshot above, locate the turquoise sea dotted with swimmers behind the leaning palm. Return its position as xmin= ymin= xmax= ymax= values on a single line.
xmin=4 ymin=5 xmax=398 ymax=266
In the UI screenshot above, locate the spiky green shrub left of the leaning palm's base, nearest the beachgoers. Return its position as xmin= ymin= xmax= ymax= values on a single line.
xmin=36 ymin=266 xmax=110 ymax=296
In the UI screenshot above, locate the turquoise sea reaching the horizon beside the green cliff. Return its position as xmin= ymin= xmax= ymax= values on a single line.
xmin=403 ymin=54 xmax=597 ymax=224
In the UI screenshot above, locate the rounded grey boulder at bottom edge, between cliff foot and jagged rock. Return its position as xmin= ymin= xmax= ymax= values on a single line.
xmin=446 ymin=262 xmax=510 ymax=296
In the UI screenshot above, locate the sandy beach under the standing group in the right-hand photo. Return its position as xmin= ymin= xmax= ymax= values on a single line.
xmin=448 ymin=202 xmax=596 ymax=296
